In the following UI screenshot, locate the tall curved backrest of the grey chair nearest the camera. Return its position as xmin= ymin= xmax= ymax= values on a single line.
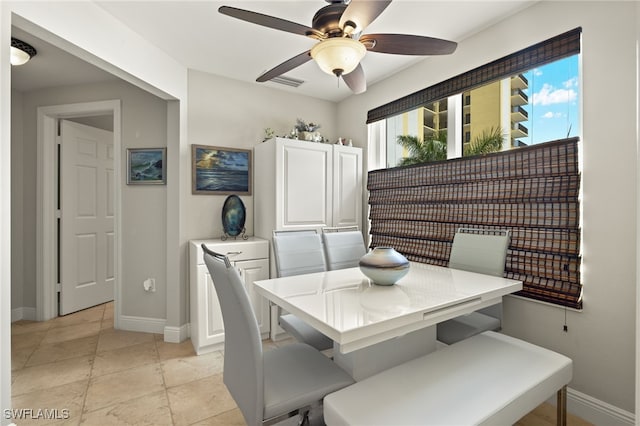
xmin=202 ymin=244 xmax=264 ymax=425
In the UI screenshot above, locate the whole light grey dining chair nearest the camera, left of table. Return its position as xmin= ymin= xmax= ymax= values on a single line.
xmin=202 ymin=244 xmax=354 ymax=426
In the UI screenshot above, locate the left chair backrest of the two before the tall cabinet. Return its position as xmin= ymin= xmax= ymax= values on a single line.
xmin=273 ymin=230 xmax=327 ymax=277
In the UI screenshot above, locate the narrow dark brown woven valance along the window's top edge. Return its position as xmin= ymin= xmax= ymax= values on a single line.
xmin=367 ymin=28 xmax=582 ymax=123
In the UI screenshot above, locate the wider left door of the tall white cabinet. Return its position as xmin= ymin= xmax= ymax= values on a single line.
xmin=276 ymin=141 xmax=332 ymax=230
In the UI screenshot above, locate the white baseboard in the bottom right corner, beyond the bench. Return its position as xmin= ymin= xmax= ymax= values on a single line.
xmin=567 ymin=388 xmax=636 ymax=426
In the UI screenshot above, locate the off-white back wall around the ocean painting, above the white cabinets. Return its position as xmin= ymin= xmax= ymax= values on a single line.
xmin=185 ymin=71 xmax=338 ymax=239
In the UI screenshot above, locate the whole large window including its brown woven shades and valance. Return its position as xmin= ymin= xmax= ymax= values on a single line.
xmin=367 ymin=28 xmax=582 ymax=309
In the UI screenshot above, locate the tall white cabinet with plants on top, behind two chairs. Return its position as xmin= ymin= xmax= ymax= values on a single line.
xmin=253 ymin=138 xmax=362 ymax=251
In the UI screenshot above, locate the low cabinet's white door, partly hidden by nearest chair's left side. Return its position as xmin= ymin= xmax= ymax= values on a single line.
xmin=196 ymin=265 xmax=224 ymax=351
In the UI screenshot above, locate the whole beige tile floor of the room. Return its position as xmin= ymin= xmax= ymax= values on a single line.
xmin=11 ymin=303 xmax=588 ymax=426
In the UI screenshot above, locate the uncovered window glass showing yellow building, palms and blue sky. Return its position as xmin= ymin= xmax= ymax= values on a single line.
xmin=386 ymin=54 xmax=580 ymax=167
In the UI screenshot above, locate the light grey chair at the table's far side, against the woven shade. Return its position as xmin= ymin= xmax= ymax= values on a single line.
xmin=437 ymin=228 xmax=510 ymax=345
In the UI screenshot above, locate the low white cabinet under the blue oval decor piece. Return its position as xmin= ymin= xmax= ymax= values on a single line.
xmin=189 ymin=237 xmax=270 ymax=355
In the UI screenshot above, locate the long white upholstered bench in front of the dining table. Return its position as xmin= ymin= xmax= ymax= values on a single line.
xmin=324 ymin=331 xmax=572 ymax=426
